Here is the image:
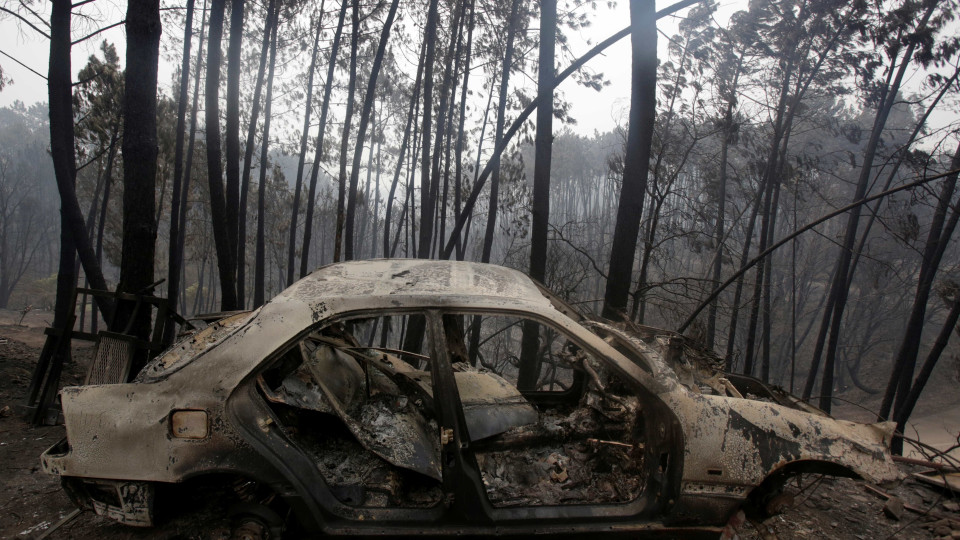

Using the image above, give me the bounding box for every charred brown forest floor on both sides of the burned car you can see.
[0,310,960,540]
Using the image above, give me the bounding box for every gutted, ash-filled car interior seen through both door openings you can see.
[257,312,667,508]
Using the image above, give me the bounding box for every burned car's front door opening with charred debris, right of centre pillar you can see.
[443,314,645,507]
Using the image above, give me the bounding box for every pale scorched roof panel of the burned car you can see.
[263,259,552,322]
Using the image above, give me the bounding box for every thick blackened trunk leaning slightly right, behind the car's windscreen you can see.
[603,0,657,320]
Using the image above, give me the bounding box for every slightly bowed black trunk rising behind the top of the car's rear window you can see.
[204,0,239,311]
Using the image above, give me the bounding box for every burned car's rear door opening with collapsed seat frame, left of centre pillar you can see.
[258,315,442,508]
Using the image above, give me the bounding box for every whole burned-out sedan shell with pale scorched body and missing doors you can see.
[41,260,899,537]
